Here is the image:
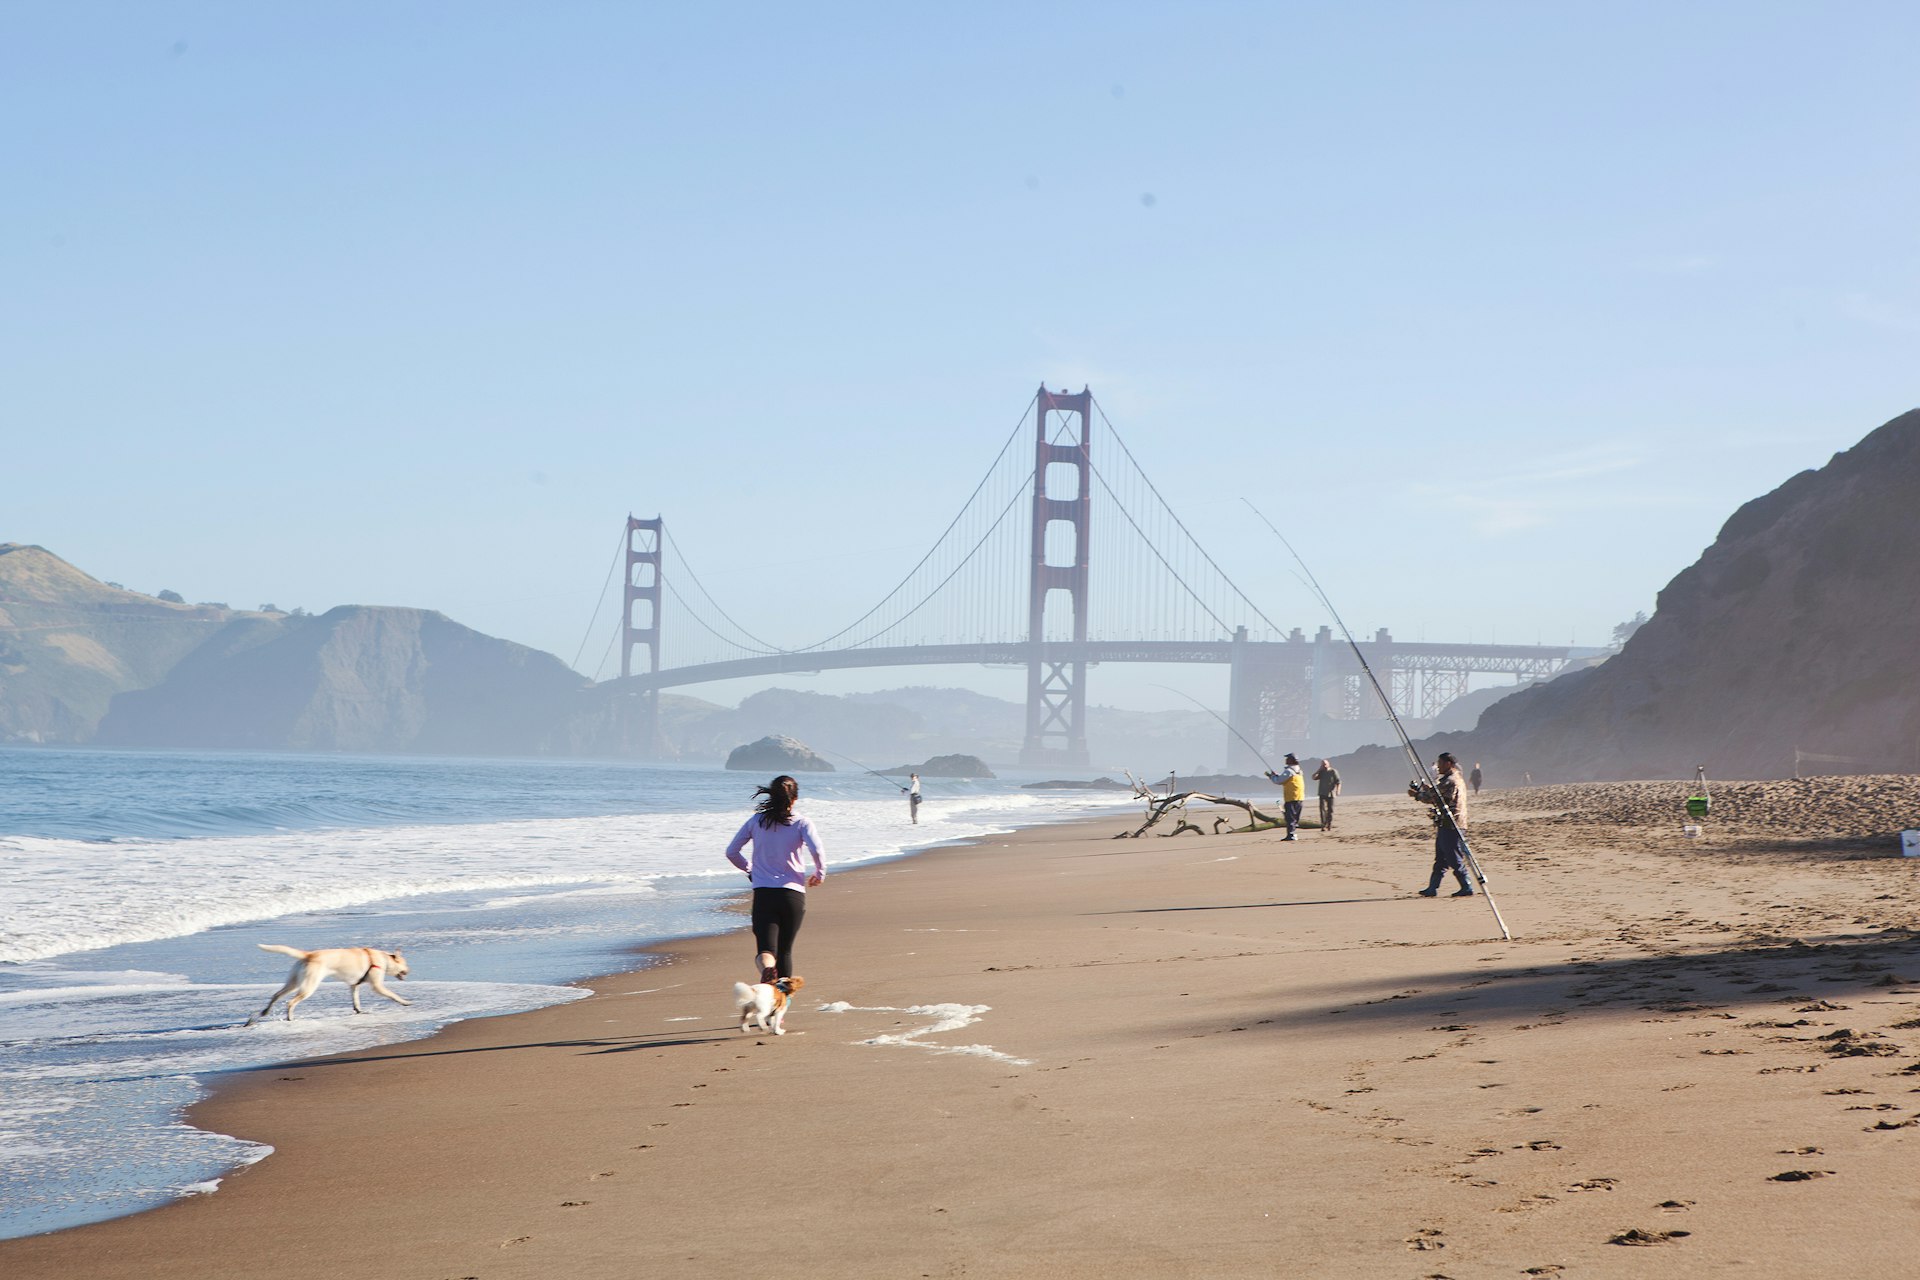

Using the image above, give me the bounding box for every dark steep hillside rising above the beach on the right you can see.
[1342,411,1920,787]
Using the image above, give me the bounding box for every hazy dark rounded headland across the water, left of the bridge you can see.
[94,604,588,754]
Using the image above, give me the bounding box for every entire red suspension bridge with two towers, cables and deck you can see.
[591,386,1592,768]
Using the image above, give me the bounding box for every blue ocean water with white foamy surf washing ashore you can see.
[0,748,1116,1238]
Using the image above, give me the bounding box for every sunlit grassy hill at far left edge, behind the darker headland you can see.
[0,543,249,743]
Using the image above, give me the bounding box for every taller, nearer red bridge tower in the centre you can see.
[1020,386,1092,768]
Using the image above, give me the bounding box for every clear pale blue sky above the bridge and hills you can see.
[0,2,1920,704]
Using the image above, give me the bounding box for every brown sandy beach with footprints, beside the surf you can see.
[0,779,1920,1280]
